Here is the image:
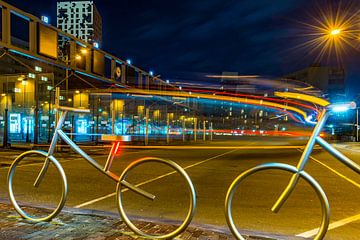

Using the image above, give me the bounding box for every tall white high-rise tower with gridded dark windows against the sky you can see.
[57,1,102,46]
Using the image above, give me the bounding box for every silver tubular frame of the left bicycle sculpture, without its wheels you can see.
[34,110,150,200]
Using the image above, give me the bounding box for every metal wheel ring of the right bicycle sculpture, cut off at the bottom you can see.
[225,163,330,240]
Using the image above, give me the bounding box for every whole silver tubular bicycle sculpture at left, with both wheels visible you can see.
[8,106,196,239]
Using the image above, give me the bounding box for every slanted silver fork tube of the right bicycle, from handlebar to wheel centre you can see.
[271,108,329,213]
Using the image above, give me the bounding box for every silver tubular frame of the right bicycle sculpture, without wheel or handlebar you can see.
[271,108,360,213]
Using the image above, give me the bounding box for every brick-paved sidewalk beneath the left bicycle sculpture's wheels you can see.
[0,202,294,240]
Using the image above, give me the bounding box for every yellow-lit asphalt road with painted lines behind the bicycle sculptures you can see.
[0,137,360,239]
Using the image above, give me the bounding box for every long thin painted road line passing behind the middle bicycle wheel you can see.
[74,149,237,208]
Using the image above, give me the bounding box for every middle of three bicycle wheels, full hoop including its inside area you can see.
[116,157,196,239]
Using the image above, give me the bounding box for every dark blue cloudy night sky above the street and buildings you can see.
[7,0,360,95]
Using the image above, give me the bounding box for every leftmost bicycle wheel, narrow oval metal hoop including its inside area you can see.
[7,150,68,222]
